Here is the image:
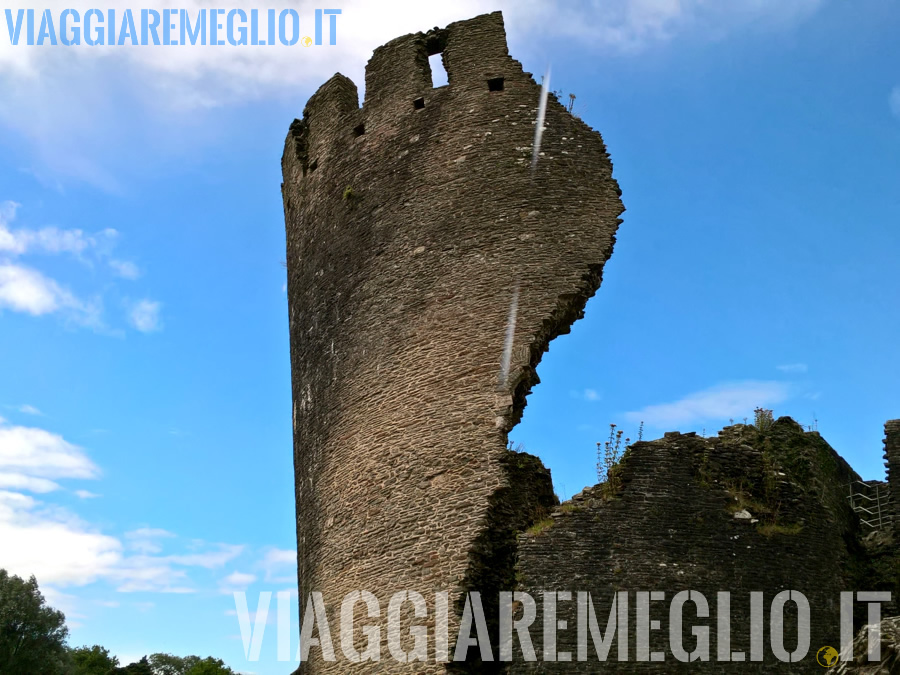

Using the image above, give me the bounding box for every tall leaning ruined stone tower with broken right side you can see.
[283,12,623,673]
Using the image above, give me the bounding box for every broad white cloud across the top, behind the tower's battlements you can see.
[0,0,822,190]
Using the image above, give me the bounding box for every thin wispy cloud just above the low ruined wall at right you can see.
[625,381,788,428]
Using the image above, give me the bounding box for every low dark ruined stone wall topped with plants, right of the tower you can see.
[511,418,867,673]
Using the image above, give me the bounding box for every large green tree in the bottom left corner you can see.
[0,569,69,675]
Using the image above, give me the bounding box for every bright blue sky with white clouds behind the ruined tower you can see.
[0,0,900,675]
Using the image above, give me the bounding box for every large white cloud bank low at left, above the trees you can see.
[0,424,250,593]
